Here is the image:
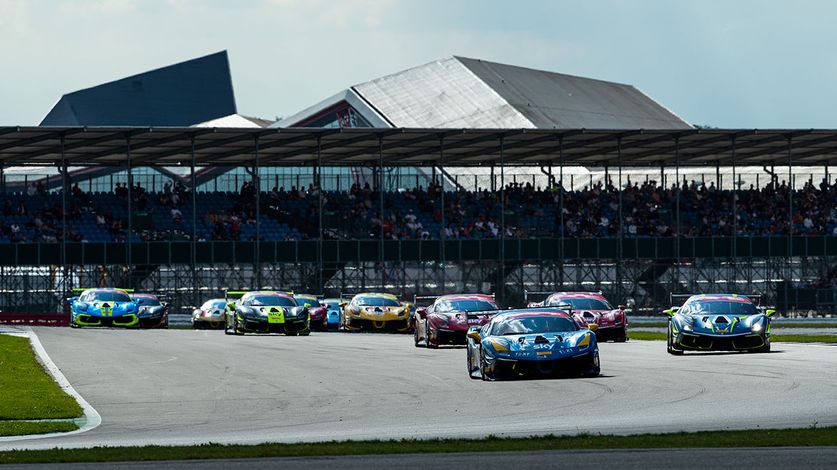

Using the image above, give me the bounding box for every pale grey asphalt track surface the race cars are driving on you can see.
[0,328,837,452]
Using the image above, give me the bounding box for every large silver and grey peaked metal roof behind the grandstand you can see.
[274,57,692,129]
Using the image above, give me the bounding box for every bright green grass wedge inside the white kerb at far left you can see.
[0,335,83,420]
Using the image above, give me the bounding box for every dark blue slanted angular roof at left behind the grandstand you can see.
[40,51,236,126]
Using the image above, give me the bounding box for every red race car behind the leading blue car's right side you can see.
[526,292,628,343]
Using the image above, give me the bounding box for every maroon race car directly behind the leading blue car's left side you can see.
[413,294,500,348]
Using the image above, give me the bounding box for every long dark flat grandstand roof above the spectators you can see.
[0,127,837,166]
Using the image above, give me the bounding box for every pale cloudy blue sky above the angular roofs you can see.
[0,0,837,129]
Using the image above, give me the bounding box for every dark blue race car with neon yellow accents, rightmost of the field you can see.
[663,294,776,355]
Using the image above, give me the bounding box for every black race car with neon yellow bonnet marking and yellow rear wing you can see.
[224,291,311,336]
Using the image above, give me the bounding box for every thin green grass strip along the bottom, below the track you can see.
[0,427,837,464]
